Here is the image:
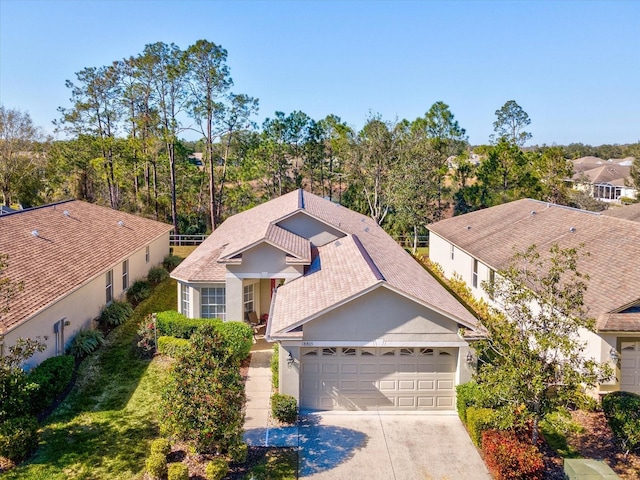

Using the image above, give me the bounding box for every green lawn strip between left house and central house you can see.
[3,280,177,480]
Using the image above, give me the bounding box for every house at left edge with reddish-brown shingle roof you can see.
[0,200,172,367]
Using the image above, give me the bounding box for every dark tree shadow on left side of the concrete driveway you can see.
[298,415,369,477]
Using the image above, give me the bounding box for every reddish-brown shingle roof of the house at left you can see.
[0,200,172,333]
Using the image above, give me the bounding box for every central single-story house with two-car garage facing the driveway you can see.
[171,190,476,410]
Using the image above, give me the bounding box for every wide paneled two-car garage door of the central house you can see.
[300,347,458,410]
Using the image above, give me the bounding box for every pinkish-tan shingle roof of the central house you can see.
[171,190,476,335]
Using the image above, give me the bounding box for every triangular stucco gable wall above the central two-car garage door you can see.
[303,287,460,342]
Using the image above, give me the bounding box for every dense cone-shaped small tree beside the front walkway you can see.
[161,326,245,453]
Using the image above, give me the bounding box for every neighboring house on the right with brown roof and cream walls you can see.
[429,199,640,393]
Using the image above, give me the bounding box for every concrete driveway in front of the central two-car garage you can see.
[298,412,491,480]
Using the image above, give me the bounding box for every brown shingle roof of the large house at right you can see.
[429,199,640,331]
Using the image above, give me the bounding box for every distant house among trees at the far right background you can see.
[571,157,638,202]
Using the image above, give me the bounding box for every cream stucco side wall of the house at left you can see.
[4,233,169,368]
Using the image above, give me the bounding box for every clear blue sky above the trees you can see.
[0,0,640,145]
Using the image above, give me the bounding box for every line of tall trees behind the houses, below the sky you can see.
[0,40,640,238]
